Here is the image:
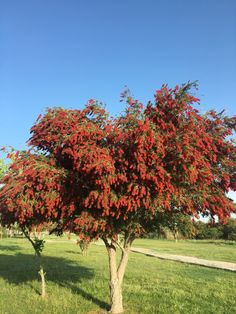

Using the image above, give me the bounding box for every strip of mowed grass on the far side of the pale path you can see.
[133,239,236,263]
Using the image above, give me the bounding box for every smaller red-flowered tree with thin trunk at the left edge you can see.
[0,151,68,297]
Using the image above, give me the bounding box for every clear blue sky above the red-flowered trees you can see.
[0,0,236,149]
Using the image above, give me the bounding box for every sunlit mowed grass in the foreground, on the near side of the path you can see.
[0,239,236,314]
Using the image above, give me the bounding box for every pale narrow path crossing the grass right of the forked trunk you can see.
[131,247,236,271]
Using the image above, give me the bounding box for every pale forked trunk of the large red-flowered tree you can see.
[104,241,130,314]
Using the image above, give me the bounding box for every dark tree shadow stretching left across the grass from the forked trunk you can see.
[0,253,109,310]
